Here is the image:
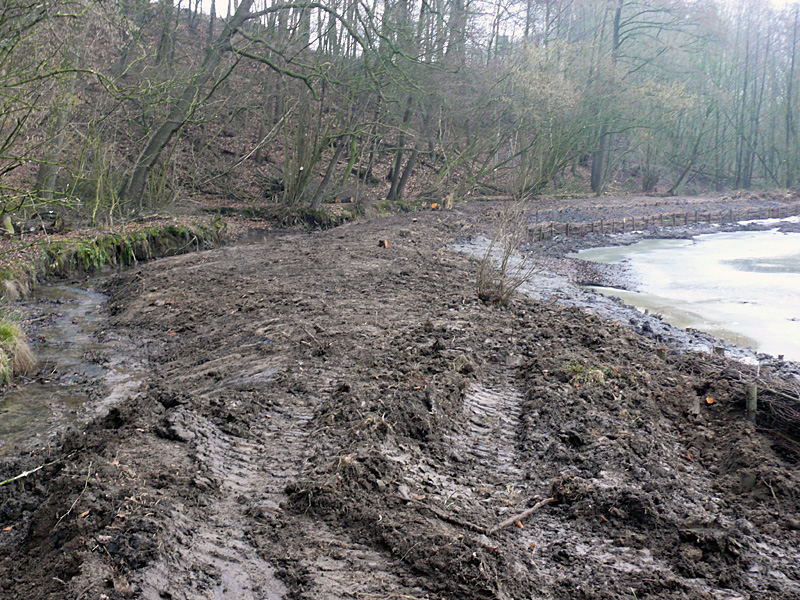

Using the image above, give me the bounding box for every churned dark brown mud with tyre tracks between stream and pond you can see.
[0,199,800,600]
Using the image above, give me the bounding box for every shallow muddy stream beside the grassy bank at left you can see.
[0,284,142,456]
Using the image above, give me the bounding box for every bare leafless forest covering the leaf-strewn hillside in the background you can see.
[0,0,800,225]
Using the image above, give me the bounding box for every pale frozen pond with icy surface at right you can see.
[573,230,800,361]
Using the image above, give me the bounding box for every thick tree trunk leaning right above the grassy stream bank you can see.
[122,0,254,210]
